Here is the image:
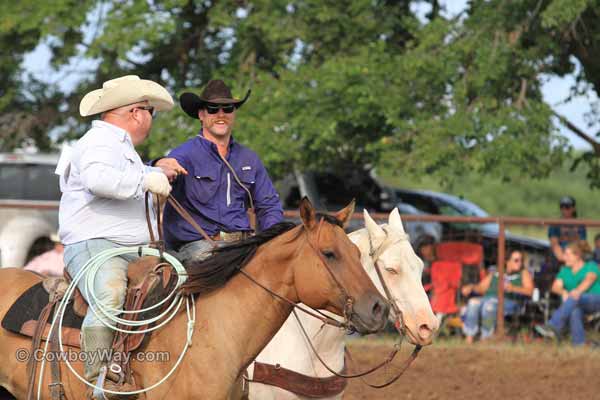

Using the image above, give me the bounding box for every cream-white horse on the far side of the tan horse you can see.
[248,209,438,400]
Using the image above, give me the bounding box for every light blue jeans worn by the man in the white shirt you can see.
[64,239,138,328]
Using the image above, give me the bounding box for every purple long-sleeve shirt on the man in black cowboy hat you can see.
[164,133,283,249]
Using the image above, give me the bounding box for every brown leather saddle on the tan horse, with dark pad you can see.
[2,257,177,400]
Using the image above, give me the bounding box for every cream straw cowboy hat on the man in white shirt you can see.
[79,75,173,117]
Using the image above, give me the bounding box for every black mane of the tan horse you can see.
[180,214,342,295]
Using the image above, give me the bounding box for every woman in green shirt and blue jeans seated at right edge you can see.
[535,242,600,346]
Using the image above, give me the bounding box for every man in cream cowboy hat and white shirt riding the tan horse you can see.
[57,75,174,399]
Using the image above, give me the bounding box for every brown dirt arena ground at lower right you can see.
[344,339,600,400]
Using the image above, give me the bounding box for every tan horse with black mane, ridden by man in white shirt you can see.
[0,199,389,400]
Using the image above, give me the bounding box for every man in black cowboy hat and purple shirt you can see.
[156,80,283,260]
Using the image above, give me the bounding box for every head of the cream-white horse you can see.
[352,208,439,346]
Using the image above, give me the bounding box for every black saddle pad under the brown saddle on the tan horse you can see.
[2,282,83,333]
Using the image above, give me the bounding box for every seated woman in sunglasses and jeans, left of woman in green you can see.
[461,250,533,344]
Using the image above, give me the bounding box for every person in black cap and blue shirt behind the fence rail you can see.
[548,196,587,264]
